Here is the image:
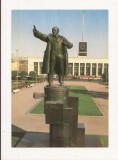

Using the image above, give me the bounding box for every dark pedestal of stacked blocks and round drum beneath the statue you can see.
[44,85,85,147]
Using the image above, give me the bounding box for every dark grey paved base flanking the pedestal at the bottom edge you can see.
[16,132,108,148]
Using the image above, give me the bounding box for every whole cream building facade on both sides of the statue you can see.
[12,56,109,77]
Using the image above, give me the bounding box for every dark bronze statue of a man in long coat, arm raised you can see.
[33,25,73,86]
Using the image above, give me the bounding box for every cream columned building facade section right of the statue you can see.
[68,56,108,77]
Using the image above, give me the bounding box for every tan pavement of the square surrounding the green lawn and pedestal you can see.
[12,81,108,135]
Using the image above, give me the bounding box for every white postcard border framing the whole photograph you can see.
[1,0,118,160]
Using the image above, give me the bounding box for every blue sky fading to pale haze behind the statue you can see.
[11,10,108,58]
